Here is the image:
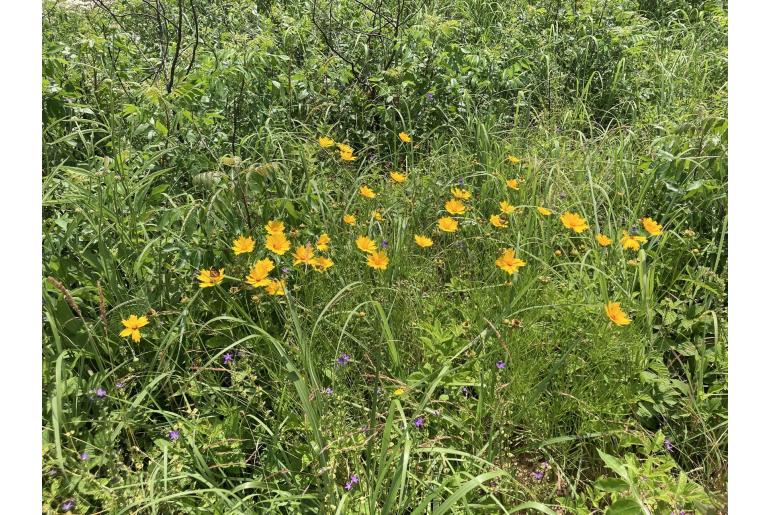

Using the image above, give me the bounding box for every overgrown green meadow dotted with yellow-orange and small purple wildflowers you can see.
[41,0,728,515]
